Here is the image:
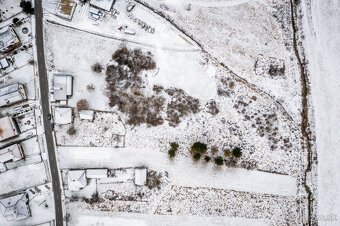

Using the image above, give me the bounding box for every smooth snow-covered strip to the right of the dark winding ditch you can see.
[303,0,340,225]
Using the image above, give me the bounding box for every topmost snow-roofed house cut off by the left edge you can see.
[0,26,21,54]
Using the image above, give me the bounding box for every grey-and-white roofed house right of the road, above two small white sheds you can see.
[52,74,73,101]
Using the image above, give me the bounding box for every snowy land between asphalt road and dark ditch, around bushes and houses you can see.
[41,0,318,225]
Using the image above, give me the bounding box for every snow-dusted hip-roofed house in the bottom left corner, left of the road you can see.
[0,193,31,221]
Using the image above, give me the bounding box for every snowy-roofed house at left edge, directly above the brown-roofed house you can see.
[0,83,27,107]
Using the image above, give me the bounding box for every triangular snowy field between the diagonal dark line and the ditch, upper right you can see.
[138,0,301,119]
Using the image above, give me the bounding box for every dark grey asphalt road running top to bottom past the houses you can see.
[35,0,63,226]
